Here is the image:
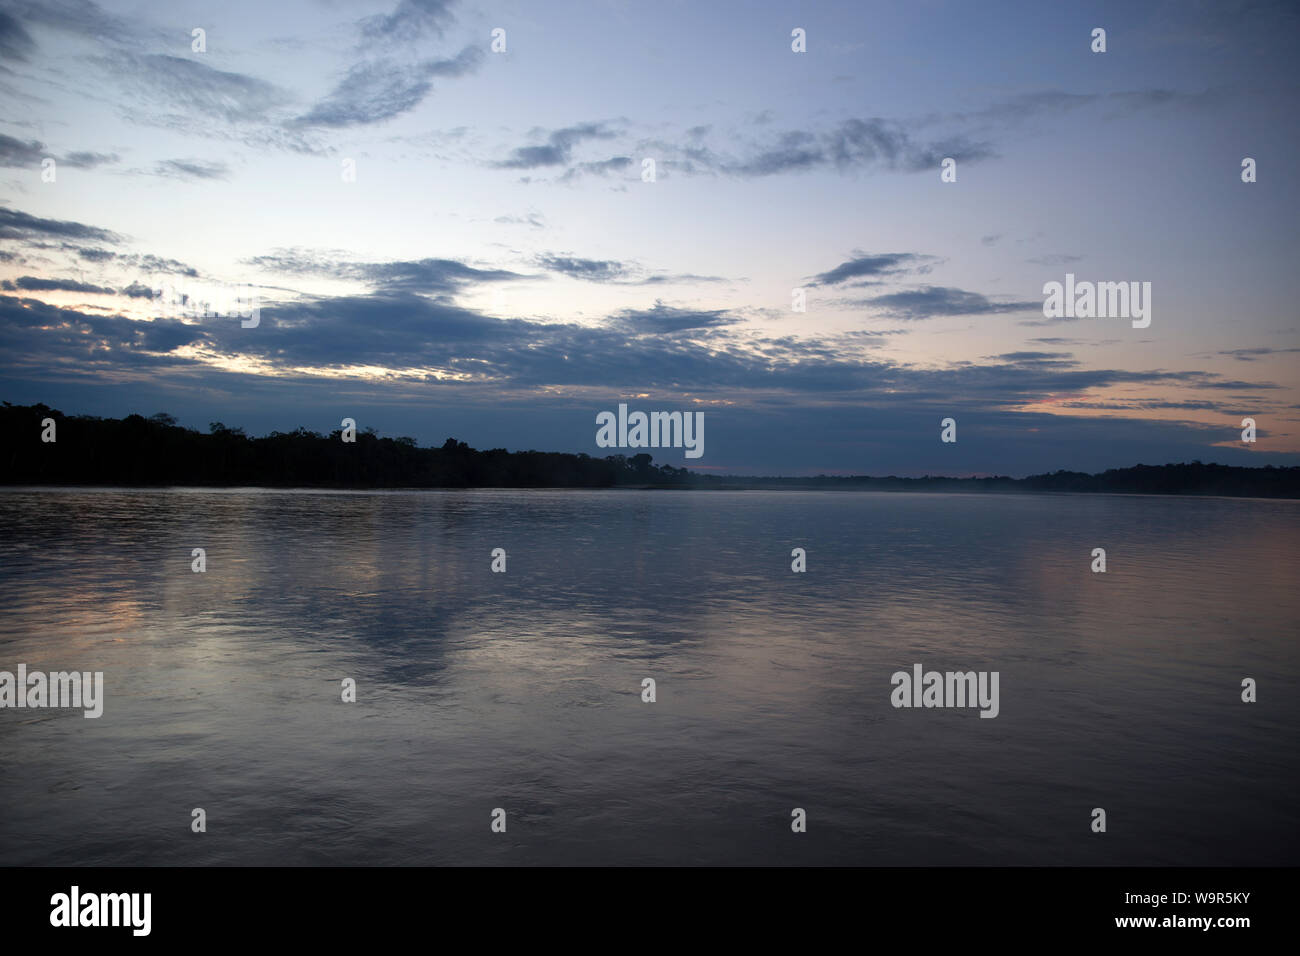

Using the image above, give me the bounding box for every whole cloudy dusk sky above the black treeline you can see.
[0,0,1300,476]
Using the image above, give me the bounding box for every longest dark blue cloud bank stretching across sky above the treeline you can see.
[0,291,1278,427]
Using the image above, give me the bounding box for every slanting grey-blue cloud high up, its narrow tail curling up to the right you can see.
[294,46,484,129]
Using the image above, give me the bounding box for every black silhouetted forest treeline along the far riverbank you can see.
[0,402,1300,498]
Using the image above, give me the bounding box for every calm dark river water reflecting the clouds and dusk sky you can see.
[0,489,1300,865]
